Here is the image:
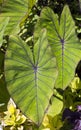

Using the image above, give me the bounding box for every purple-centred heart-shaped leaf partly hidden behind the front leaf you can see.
[34,5,81,88]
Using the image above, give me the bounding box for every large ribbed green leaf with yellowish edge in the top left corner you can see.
[0,0,36,34]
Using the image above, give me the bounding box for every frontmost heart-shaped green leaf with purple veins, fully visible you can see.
[5,30,57,125]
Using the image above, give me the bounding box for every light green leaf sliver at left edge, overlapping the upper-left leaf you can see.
[0,17,9,47]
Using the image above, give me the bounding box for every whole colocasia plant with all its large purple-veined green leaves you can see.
[0,0,81,130]
